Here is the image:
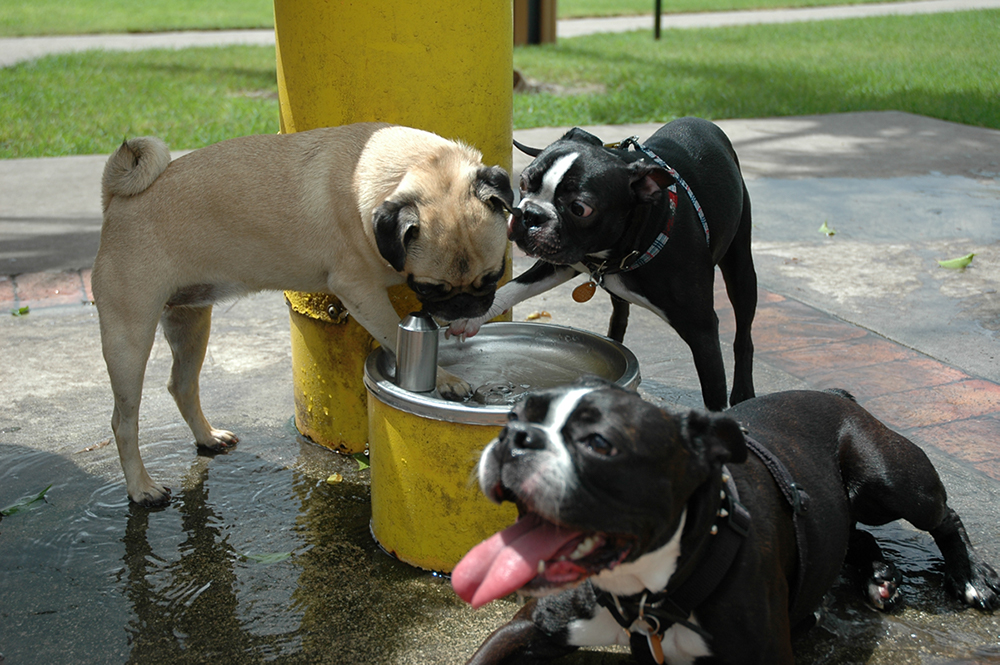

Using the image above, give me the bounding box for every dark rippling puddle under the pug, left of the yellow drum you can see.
[0,426,476,665]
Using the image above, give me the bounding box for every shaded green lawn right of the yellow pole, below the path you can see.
[514,11,1000,128]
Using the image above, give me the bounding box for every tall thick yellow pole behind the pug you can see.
[274,0,513,452]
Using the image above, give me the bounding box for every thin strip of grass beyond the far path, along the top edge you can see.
[0,0,916,37]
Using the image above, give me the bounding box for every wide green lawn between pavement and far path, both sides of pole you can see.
[0,11,1000,158]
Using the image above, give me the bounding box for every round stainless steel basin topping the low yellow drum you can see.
[365,322,640,425]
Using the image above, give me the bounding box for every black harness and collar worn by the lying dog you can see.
[594,437,809,665]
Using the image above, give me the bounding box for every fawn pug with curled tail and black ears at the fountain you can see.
[92,123,514,505]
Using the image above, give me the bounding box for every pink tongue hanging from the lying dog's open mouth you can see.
[451,513,581,607]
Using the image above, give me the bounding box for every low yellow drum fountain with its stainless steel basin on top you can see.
[365,323,639,572]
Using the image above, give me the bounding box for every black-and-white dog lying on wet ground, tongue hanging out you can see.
[452,380,1000,665]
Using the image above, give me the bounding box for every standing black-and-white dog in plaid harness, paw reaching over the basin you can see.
[449,118,757,411]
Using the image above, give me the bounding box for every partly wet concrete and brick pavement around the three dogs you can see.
[0,112,1000,665]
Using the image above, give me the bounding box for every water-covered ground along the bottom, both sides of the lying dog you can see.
[0,429,1000,665]
